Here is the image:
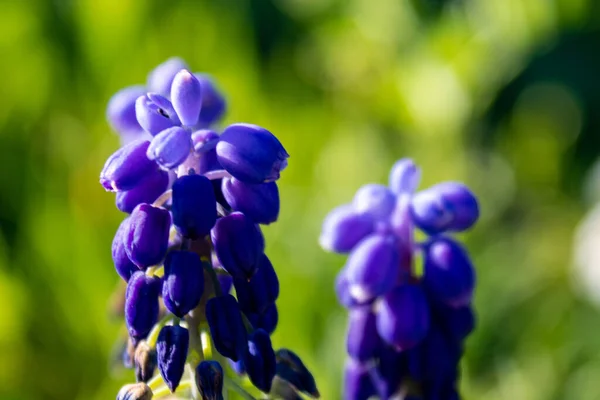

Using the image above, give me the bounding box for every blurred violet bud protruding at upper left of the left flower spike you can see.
[106,86,146,134]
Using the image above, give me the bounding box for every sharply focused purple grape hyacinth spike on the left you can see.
[100,58,318,400]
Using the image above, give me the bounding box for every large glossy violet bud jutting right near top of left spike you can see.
[217,124,289,183]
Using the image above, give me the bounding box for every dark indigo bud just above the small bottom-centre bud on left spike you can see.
[206,294,248,361]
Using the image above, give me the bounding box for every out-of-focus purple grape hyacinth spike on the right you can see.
[320,159,479,400]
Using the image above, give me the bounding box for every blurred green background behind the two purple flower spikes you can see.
[0,0,600,400]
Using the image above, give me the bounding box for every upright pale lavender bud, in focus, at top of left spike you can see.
[171,69,202,126]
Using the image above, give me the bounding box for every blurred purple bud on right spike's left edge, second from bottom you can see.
[346,306,381,362]
